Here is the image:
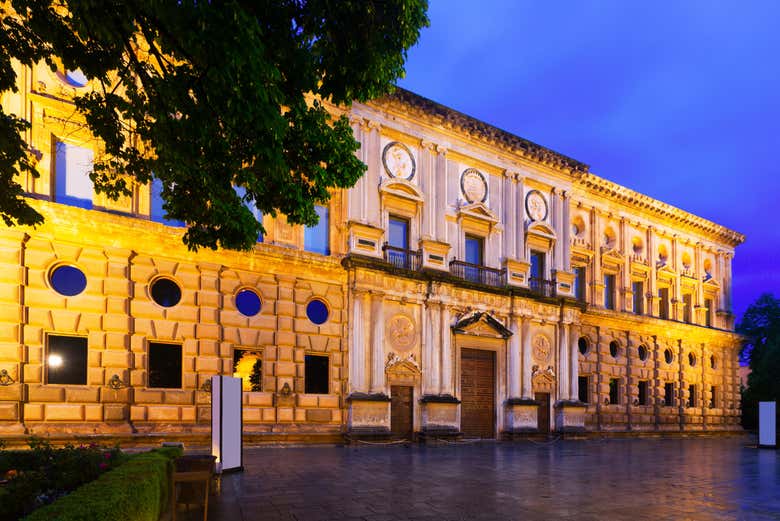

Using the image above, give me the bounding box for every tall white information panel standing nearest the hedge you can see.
[211,376,244,472]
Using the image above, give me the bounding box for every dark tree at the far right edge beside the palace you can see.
[736,293,780,428]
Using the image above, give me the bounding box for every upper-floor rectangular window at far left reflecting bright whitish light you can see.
[54,141,94,209]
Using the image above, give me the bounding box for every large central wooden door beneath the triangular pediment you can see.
[460,349,496,438]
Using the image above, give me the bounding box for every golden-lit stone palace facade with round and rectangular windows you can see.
[0,62,744,441]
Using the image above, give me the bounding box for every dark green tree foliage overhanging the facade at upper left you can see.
[0,0,428,249]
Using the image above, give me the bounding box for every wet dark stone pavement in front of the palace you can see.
[187,438,780,521]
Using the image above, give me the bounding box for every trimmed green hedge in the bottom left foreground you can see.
[25,447,181,521]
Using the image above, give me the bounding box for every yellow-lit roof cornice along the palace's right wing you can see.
[575,173,745,246]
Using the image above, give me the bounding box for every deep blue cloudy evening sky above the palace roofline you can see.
[399,0,780,318]
